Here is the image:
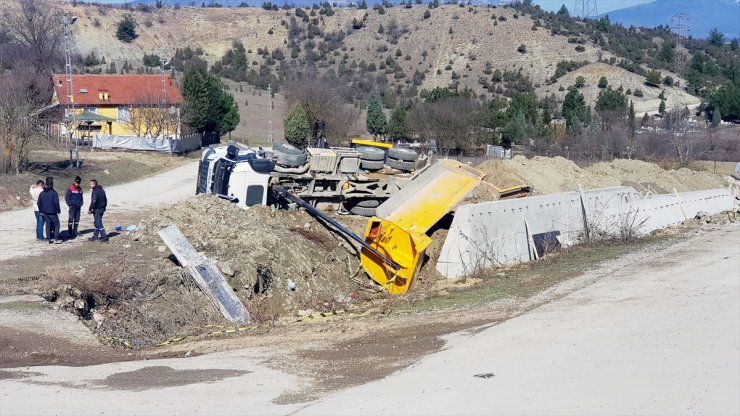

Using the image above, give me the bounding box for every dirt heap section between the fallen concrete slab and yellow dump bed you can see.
[131,196,358,321]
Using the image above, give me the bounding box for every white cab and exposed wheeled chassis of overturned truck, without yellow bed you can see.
[196,143,428,216]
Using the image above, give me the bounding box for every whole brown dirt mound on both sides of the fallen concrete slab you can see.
[45,195,364,347]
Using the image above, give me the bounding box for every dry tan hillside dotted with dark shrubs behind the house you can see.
[46,4,699,111]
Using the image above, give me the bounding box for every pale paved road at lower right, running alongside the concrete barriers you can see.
[298,225,740,415]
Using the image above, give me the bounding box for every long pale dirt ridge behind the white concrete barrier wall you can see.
[478,156,727,199]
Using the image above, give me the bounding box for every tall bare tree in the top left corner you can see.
[0,0,64,73]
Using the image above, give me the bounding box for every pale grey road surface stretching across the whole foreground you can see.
[0,224,740,415]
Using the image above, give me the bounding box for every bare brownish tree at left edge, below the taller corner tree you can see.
[0,69,52,174]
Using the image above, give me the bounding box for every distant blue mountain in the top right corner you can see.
[599,0,740,40]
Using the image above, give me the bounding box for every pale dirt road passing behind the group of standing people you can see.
[0,162,197,261]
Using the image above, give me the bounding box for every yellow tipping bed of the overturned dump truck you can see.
[360,159,485,294]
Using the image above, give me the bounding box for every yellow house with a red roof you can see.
[52,74,183,137]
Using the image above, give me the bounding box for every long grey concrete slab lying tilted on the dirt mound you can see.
[159,224,251,325]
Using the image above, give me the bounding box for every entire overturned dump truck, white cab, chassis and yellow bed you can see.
[197,145,530,294]
